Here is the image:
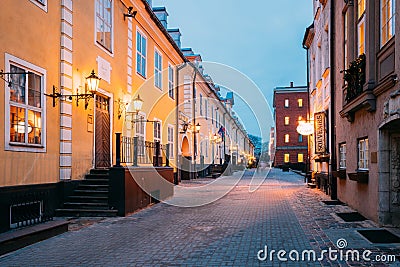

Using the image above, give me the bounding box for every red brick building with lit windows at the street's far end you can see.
[273,82,308,169]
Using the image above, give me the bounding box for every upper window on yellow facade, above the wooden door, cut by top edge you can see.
[96,0,112,52]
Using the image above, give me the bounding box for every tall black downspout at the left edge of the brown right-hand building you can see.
[329,0,337,199]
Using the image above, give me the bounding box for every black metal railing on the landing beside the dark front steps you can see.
[116,133,169,167]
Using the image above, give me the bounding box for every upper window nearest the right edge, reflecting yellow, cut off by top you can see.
[380,0,396,47]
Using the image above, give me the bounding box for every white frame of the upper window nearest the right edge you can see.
[379,0,396,48]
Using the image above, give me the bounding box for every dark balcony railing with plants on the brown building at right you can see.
[342,54,366,103]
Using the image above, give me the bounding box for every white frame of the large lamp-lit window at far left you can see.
[4,53,47,153]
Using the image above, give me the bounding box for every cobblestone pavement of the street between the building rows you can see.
[0,169,400,266]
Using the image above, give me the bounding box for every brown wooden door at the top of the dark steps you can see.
[95,96,111,168]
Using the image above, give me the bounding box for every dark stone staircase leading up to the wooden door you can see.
[56,169,117,217]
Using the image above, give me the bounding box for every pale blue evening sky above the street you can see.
[153,0,312,138]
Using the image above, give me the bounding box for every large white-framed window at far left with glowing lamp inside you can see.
[5,54,46,152]
